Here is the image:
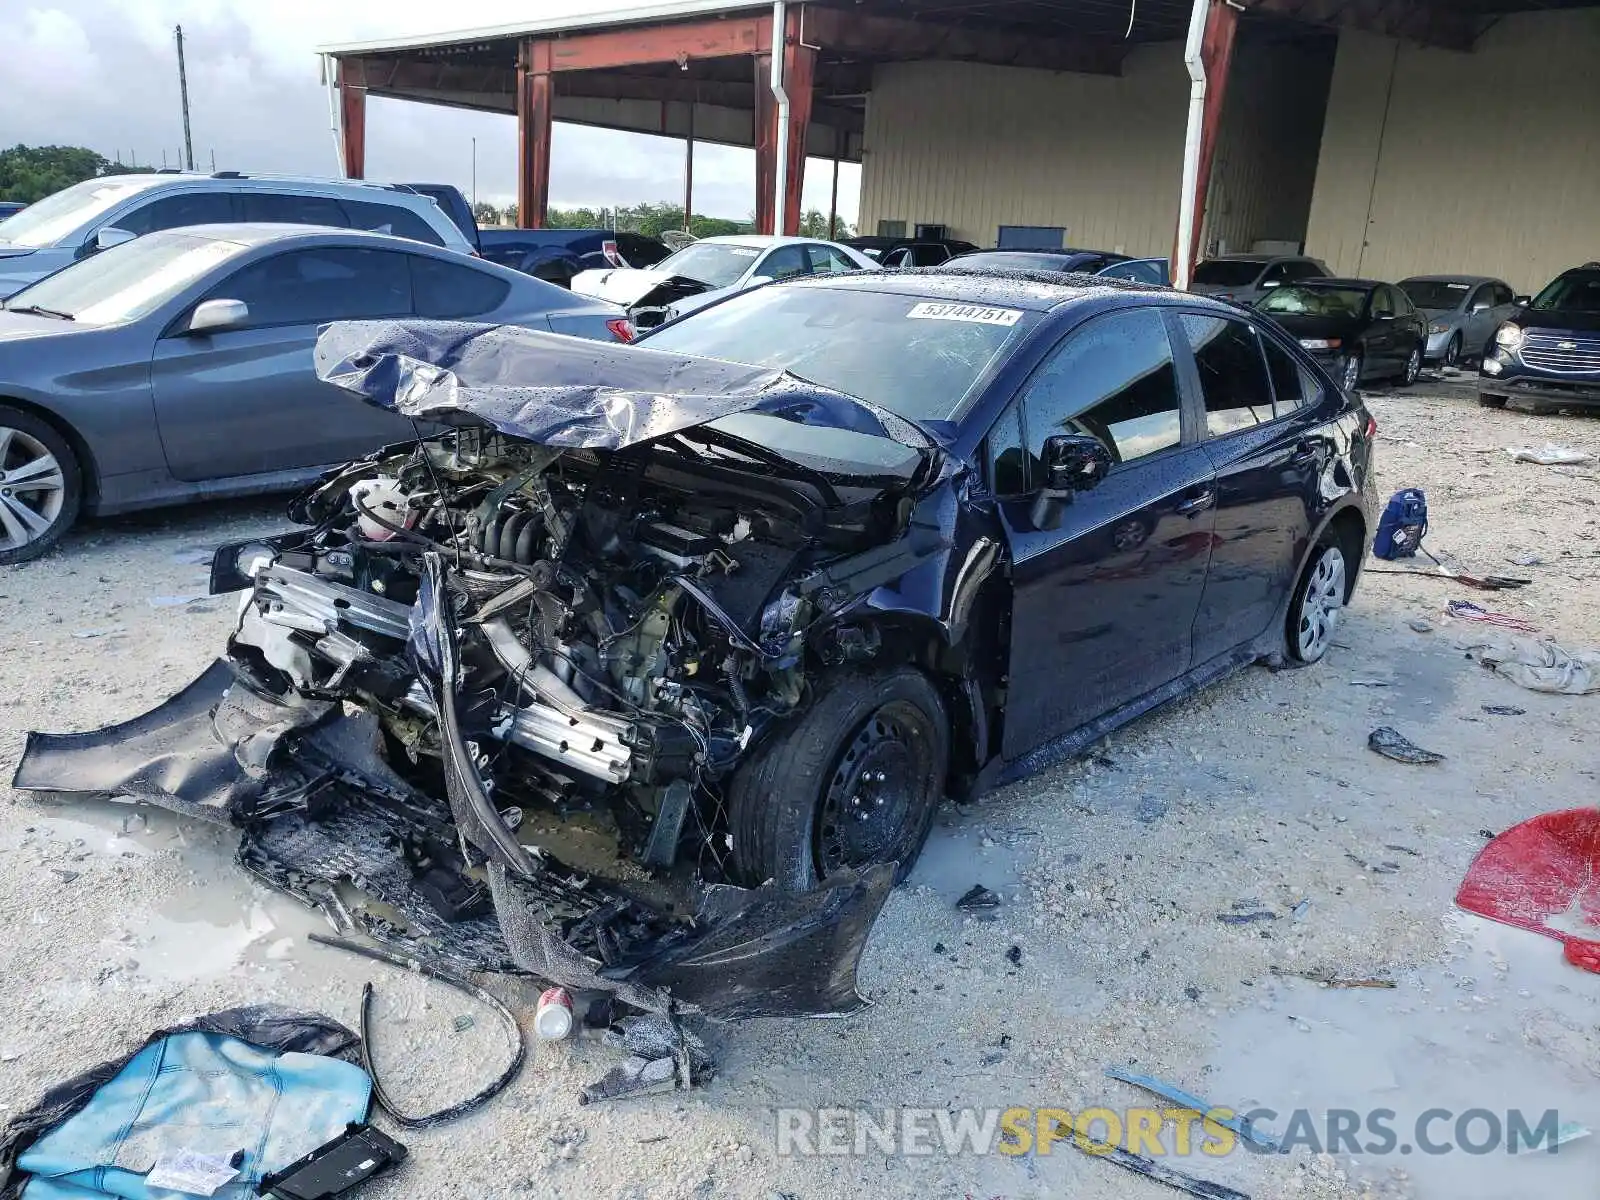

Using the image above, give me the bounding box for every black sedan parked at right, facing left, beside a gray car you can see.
[1254,278,1427,392]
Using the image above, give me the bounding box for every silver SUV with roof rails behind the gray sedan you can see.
[0,171,472,299]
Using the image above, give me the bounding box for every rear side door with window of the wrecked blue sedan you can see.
[1179,312,1336,666]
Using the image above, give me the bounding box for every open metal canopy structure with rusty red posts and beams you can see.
[322,0,1594,232]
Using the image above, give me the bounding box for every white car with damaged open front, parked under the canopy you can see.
[573,235,880,330]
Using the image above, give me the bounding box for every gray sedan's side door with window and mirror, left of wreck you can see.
[150,245,413,480]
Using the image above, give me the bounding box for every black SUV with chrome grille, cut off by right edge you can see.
[1478,262,1600,413]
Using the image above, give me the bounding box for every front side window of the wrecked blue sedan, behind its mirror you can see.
[1022,309,1182,478]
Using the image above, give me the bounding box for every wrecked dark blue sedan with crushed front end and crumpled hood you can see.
[16,270,1376,1016]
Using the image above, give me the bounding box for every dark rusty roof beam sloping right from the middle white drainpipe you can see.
[805,5,1126,75]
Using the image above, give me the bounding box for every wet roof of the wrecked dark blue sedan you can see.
[778,266,1177,312]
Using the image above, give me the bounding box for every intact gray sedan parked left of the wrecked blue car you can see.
[0,224,626,563]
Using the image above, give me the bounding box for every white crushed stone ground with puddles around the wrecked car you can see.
[0,378,1600,1200]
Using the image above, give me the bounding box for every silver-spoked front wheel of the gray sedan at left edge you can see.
[0,405,83,566]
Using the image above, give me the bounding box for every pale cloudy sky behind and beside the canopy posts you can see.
[0,0,861,221]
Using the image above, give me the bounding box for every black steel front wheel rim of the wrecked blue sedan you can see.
[816,704,926,875]
